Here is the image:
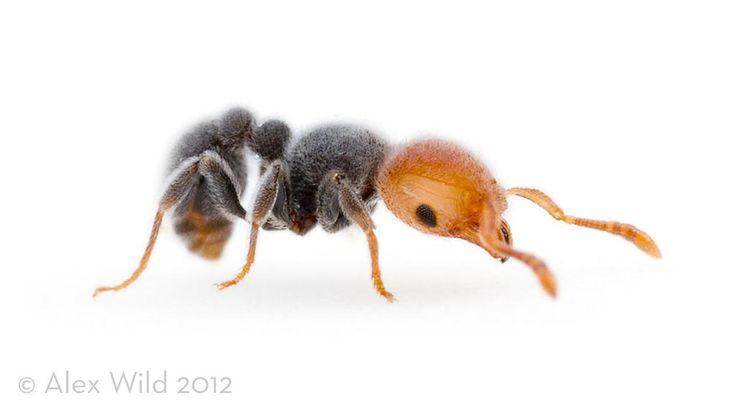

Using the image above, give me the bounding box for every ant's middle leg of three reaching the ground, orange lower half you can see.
[217,161,284,290]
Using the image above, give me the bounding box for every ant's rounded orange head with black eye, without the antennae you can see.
[378,140,511,252]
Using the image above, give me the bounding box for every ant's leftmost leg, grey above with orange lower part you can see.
[94,157,199,297]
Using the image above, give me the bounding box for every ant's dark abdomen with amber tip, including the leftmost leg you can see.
[95,109,282,295]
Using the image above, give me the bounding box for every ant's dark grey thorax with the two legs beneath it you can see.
[218,125,393,301]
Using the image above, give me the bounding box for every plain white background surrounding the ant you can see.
[0,0,736,402]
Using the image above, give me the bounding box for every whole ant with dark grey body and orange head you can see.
[95,109,661,301]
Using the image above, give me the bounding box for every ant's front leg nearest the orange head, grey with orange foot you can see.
[329,172,396,302]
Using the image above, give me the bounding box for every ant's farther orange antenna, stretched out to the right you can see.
[506,188,662,257]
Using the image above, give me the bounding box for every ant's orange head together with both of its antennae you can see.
[378,140,660,296]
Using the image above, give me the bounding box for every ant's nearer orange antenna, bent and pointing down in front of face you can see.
[480,206,557,297]
